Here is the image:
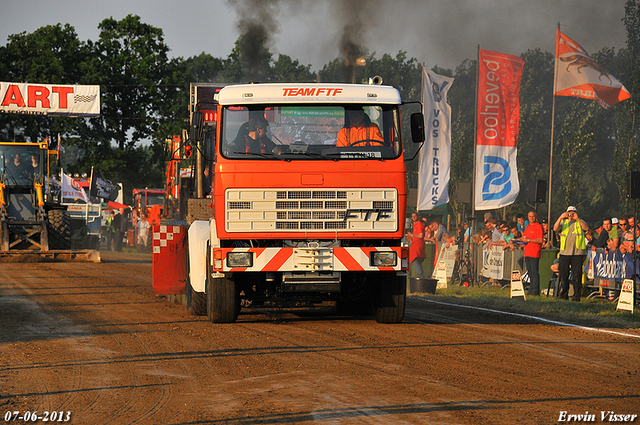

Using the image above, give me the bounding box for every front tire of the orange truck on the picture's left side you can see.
[207,273,240,323]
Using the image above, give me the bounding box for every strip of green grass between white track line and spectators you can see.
[412,285,640,329]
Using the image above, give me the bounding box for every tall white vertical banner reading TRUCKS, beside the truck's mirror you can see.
[418,67,453,210]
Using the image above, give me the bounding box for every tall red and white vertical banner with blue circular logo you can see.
[474,50,524,210]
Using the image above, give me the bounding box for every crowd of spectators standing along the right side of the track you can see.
[407,206,640,301]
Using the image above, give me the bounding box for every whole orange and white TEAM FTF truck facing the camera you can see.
[154,83,424,323]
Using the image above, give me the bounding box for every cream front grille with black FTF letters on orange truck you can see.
[225,189,398,235]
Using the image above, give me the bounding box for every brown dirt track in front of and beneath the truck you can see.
[0,253,640,424]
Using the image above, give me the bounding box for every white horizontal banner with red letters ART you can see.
[0,81,100,117]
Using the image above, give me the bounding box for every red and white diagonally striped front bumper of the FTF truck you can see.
[212,247,409,272]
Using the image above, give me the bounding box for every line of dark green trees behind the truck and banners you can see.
[0,0,640,222]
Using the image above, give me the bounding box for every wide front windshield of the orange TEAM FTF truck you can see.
[221,104,402,160]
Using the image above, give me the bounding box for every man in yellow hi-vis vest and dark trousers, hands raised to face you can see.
[553,207,589,301]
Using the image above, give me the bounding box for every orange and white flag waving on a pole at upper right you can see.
[555,28,631,109]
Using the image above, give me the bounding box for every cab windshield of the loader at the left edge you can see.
[0,145,42,186]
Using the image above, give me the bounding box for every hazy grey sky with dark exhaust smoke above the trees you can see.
[0,0,626,72]
